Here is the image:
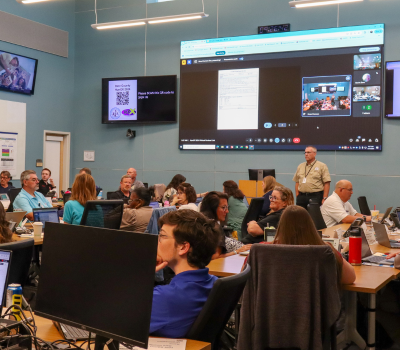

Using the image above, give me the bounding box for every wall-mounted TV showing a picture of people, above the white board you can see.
[0,50,38,95]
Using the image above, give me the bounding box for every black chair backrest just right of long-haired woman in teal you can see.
[81,200,124,230]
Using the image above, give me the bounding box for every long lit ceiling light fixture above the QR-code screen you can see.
[92,12,209,29]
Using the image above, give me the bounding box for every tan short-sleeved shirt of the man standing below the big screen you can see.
[293,160,331,193]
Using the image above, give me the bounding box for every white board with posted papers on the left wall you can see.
[0,100,26,180]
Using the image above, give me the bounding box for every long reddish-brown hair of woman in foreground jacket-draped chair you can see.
[274,205,325,245]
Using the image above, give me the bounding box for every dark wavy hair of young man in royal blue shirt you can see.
[158,209,220,269]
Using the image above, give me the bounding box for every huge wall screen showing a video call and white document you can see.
[179,24,384,151]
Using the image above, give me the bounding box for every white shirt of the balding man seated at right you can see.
[321,192,357,227]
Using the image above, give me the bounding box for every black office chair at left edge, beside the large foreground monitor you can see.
[0,238,35,305]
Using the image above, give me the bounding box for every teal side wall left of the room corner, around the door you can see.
[0,0,75,187]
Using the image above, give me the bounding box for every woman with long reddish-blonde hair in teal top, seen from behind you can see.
[63,173,96,225]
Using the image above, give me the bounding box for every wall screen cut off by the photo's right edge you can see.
[385,61,400,118]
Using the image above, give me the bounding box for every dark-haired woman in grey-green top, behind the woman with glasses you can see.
[223,180,247,239]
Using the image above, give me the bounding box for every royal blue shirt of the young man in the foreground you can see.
[150,268,217,338]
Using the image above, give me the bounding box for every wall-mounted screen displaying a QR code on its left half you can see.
[102,75,176,125]
